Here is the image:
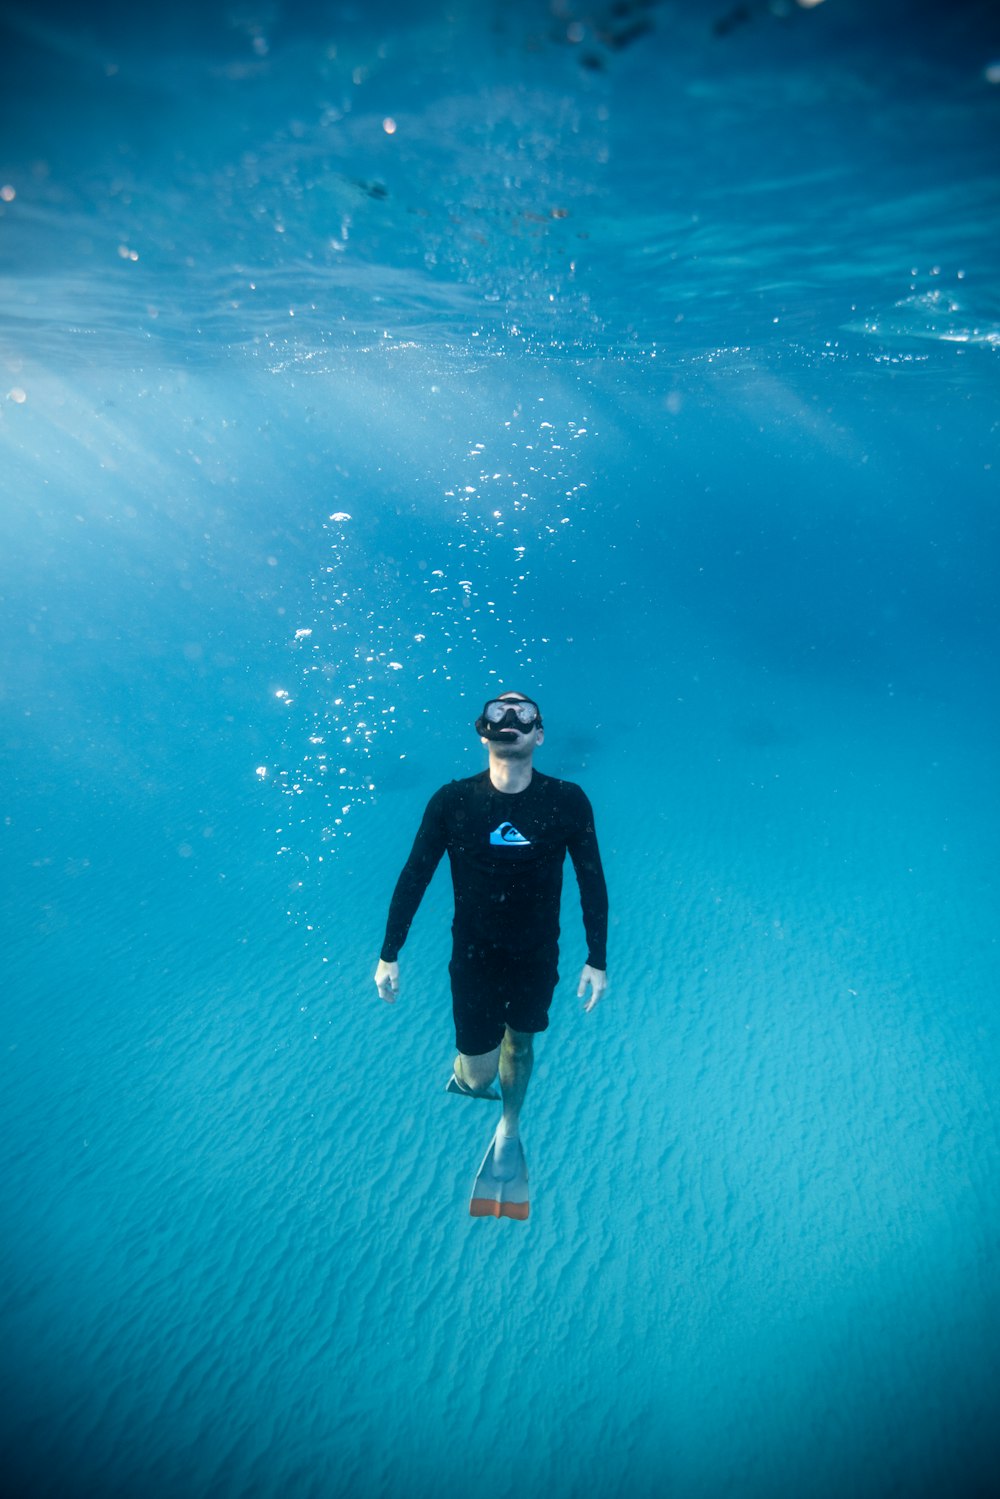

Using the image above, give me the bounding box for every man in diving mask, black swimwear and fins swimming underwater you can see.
[375,693,607,1219]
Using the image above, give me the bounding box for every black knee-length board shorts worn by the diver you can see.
[448,937,559,1057]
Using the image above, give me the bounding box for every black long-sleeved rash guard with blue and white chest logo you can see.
[382,770,607,970]
